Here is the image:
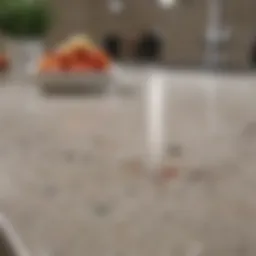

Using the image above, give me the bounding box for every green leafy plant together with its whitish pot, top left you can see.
[0,0,50,75]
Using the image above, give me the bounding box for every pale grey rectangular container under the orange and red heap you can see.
[38,73,112,94]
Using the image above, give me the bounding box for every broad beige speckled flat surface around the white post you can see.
[0,68,256,256]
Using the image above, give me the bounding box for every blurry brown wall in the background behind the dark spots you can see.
[47,0,256,67]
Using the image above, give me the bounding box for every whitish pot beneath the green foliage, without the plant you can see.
[7,39,43,78]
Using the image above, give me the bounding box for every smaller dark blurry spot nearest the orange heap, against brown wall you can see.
[103,34,123,59]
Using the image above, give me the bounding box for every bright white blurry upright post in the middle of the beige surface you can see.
[145,74,165,171]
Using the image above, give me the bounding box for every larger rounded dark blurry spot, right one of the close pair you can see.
[136,32,162,62]
